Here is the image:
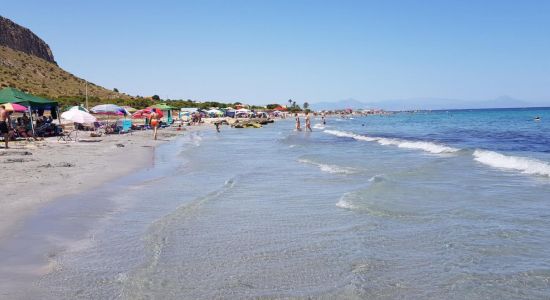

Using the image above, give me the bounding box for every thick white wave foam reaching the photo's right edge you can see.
[473,150,550,177]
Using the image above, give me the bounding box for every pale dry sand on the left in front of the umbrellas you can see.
[0,126,197,240]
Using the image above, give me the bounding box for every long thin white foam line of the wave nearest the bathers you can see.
[324,130,460,154]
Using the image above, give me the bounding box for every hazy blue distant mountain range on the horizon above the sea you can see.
[311,96,550,111]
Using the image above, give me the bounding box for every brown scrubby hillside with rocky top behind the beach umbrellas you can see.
[0,16,130,99]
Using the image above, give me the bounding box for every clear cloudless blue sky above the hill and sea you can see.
[0,0,550,104]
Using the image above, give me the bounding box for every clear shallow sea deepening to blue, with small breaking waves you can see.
[0,108,550,299]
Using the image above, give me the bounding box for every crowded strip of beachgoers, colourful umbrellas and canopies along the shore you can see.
[0,96,388,149]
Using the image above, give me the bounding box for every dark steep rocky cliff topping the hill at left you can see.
[0,16,55,63]
